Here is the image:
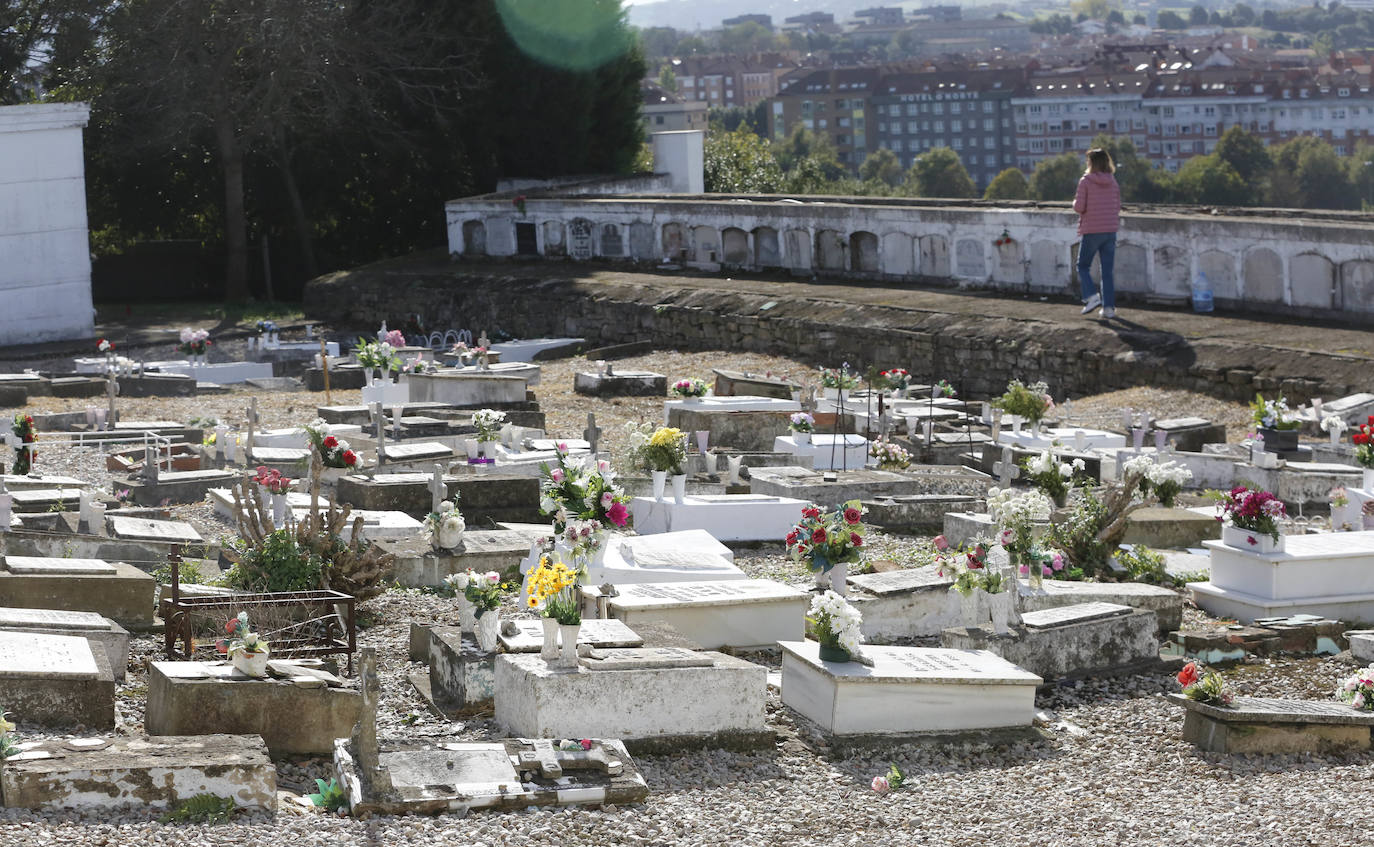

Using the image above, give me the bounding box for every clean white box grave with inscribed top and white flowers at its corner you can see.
[779,641,1043,737]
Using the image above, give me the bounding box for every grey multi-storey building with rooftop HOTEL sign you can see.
[870,69,1025,187]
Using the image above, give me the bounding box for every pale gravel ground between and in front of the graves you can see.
[0,348,1374,847]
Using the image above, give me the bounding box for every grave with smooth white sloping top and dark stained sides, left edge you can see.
[0,630,114,729]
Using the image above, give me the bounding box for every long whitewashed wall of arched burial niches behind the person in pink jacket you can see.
[447,195,1374,320]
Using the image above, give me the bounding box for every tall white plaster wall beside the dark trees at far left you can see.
[0,103,95,345]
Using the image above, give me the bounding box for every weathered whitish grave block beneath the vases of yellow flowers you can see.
[496,650,772,749]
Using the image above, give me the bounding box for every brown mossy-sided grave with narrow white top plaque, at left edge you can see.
[0,556,157,630]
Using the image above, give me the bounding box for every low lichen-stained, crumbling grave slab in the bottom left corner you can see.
[0,734,276,811]
